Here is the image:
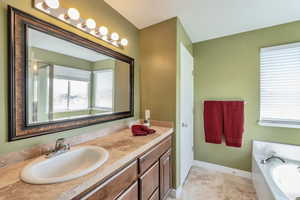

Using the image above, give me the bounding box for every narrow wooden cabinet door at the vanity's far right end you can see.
[159,149,172,199]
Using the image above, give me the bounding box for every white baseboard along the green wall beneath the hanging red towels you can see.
[193,160,251,179]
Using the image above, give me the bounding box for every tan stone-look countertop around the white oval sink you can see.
[0,126,173,200]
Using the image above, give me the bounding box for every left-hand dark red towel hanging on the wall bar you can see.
[203,101,223,144]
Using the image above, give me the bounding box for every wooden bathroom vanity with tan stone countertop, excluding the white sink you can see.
[0,124,173,200]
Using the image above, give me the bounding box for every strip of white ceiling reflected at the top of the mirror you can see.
[28,29,109,62]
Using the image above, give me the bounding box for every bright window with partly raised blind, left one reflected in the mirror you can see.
[53,66,90,112]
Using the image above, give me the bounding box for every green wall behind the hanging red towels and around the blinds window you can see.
[193,22,300,171]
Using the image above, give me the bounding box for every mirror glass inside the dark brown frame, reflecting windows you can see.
[27,29,130,124]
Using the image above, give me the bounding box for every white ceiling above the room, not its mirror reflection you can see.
[104,0,300,42]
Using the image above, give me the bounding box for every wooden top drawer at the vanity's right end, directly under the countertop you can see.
[139,137,171,174]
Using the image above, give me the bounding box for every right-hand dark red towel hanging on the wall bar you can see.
[223,101,244,147]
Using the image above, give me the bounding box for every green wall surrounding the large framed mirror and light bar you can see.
[0,0,139,154]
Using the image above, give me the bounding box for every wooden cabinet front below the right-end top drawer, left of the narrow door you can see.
[139,162,159,200]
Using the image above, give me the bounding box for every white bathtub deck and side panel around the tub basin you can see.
[252,141,300,200]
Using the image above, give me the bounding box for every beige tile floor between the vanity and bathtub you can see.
[167,167,257,200]
